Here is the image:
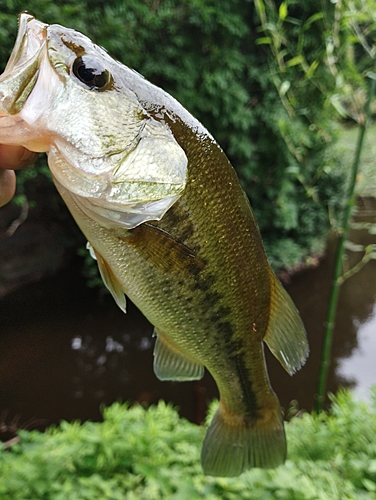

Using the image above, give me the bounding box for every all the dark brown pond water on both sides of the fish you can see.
[0,200,376,439]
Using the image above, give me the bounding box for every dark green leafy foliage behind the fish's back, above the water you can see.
[0,0,374,270]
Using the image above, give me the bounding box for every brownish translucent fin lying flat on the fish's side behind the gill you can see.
[122,223,205,274]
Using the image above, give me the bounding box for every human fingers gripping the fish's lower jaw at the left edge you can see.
[0,144,38,207]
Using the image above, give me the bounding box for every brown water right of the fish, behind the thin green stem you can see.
[273,195,376,408]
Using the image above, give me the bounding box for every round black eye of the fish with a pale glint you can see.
[72,55,111,90]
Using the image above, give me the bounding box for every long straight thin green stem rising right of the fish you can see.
[315,74,376,412]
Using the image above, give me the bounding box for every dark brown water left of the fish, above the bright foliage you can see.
[0,265,216,437]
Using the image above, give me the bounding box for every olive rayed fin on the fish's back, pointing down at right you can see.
[264,274,309,375]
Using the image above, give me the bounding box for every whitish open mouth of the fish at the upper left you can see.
[0,12,47,116]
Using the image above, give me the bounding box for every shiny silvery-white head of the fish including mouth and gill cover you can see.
[0,13,187,229]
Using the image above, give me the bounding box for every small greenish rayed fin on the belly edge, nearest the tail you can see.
[154,330,204,382]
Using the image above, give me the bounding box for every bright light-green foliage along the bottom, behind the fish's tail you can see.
[0,389,376,500]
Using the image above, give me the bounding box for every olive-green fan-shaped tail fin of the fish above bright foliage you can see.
[201,397,286,477]
